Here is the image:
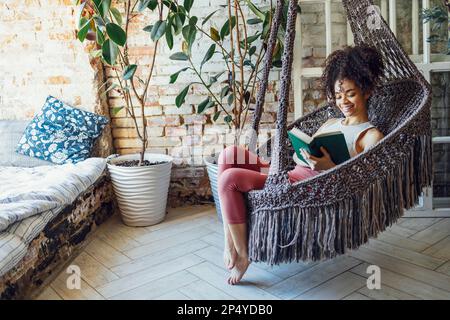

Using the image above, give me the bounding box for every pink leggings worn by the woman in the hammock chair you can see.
[218,146,319,224]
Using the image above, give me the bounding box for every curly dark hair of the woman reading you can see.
[320,46,384,101]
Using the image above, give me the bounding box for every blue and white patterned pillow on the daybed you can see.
[16,96,108,164]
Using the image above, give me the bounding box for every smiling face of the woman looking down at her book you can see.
[334,79,370,118]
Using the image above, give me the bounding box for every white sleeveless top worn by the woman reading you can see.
[294,118,375,166]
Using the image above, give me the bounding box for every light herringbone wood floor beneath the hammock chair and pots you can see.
[38,205,450,300]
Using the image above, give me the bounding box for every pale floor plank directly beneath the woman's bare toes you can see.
[188,262,278,300]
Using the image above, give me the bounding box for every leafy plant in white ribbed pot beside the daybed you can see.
[77,0,189,226]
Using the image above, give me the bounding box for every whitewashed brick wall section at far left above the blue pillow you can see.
[0,0,112,156]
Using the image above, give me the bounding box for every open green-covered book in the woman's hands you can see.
[288,128,350,165]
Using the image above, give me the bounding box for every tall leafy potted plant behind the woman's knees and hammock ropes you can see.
[170,0,287,219]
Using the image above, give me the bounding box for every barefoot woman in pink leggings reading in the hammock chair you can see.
[218,46,383,285]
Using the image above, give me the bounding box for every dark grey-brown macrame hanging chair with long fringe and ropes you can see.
[245,0,432,264]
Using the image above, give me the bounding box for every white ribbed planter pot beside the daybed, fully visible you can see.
[108,153,173,227]
